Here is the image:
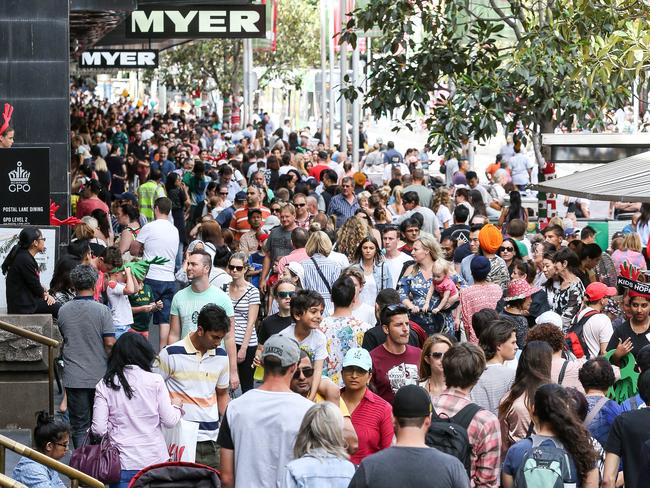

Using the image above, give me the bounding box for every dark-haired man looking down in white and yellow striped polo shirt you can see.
[157,304,230,469]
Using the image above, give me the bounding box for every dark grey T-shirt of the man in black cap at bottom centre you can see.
[346,446,469,488]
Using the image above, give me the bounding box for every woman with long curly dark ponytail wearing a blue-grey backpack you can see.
[501,383,599,488]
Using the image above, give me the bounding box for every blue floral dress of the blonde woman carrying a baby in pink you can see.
[399,271,454,335]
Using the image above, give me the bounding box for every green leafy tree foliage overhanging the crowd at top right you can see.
[341,0,650,162]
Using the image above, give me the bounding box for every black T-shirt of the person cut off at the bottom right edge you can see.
[605,408,650,488]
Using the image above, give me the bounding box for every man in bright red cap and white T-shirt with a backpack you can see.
[576,281,616,358]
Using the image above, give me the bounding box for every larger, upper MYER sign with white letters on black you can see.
[125,5,266,39]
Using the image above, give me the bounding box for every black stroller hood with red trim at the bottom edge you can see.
[129,461,221,488]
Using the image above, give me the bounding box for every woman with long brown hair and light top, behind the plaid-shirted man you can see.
[499,341,553,454]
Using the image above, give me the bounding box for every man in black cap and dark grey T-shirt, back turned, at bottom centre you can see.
[348,385,469,488]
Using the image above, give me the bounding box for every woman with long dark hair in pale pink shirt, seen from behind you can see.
[92,332,182,488]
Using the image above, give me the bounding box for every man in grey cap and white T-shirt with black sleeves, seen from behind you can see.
[217,334,313,488]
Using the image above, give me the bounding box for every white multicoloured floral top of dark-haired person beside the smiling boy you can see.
[320,317,372,388]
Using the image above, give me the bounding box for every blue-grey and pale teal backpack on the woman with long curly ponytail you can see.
[514,434,577,488]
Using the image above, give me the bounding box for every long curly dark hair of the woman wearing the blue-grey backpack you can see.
[534,383,598,483]
